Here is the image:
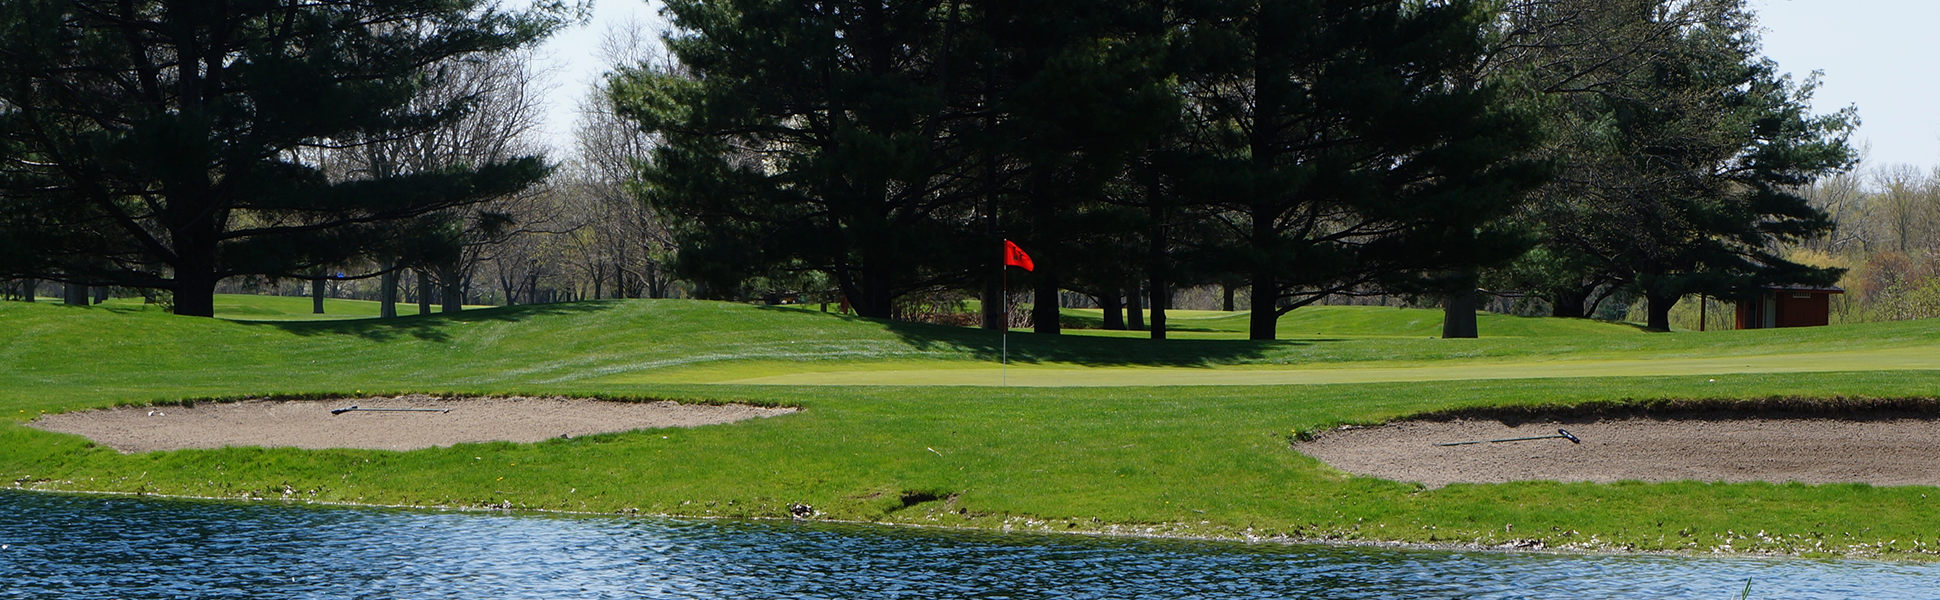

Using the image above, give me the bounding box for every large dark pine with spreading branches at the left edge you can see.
[0,0,563,317]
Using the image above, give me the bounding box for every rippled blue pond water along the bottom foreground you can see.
[0,491,1940,598]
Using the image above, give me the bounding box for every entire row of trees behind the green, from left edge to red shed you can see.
[0,0,1855,338]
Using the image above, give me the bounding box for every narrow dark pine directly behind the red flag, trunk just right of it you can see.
[976,0,1180,334]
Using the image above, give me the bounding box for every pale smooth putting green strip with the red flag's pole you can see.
[708,348,1940,386]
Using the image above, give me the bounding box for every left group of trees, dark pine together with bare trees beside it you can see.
[0,0,679,317]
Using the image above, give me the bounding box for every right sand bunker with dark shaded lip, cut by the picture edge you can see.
[1294,412,1940,487]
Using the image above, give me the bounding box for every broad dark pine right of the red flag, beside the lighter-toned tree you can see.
[1181,0,1546,340]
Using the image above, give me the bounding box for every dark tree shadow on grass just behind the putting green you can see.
[759,307,1325,367]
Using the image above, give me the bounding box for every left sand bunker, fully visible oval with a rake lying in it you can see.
[29,396,795,452]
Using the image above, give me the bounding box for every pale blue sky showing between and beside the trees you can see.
[545,0,1940,167]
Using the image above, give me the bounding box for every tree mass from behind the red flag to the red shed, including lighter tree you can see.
[611,0,1855,340]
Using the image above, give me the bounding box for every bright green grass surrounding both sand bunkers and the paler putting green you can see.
[0,299,1940,557]
